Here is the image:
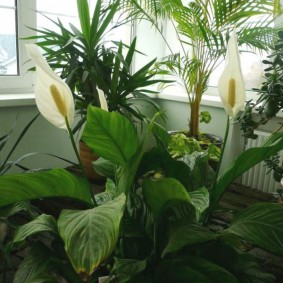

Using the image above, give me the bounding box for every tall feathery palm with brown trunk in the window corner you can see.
[123,0,280,137]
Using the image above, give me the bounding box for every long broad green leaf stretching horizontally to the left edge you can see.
[0,169,92,207]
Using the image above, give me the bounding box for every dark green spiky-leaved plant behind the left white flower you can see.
[26,0,166,132]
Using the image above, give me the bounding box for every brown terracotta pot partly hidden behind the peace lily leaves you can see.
[79,141,105,181]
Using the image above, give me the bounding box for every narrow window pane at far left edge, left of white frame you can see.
[0,6,18,76]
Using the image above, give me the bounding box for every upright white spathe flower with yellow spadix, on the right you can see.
[218,30,246,117]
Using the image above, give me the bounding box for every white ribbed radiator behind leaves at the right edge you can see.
[241,131,282,193]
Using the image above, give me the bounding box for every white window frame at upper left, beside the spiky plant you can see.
[0,0,36,95]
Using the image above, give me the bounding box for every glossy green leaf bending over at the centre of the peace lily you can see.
[142,178,191,221]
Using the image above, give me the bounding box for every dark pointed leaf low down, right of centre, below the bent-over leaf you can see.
[162,221,217,257]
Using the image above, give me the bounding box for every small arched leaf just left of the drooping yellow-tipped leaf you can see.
[13,214,57,243]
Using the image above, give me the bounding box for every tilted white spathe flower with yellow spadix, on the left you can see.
[26,44,75,129]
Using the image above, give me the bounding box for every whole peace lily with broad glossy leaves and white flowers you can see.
[0,26,283,283]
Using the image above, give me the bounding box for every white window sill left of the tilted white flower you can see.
[0,93,35,107]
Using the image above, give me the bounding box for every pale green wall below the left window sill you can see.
[0,106,76,172]
